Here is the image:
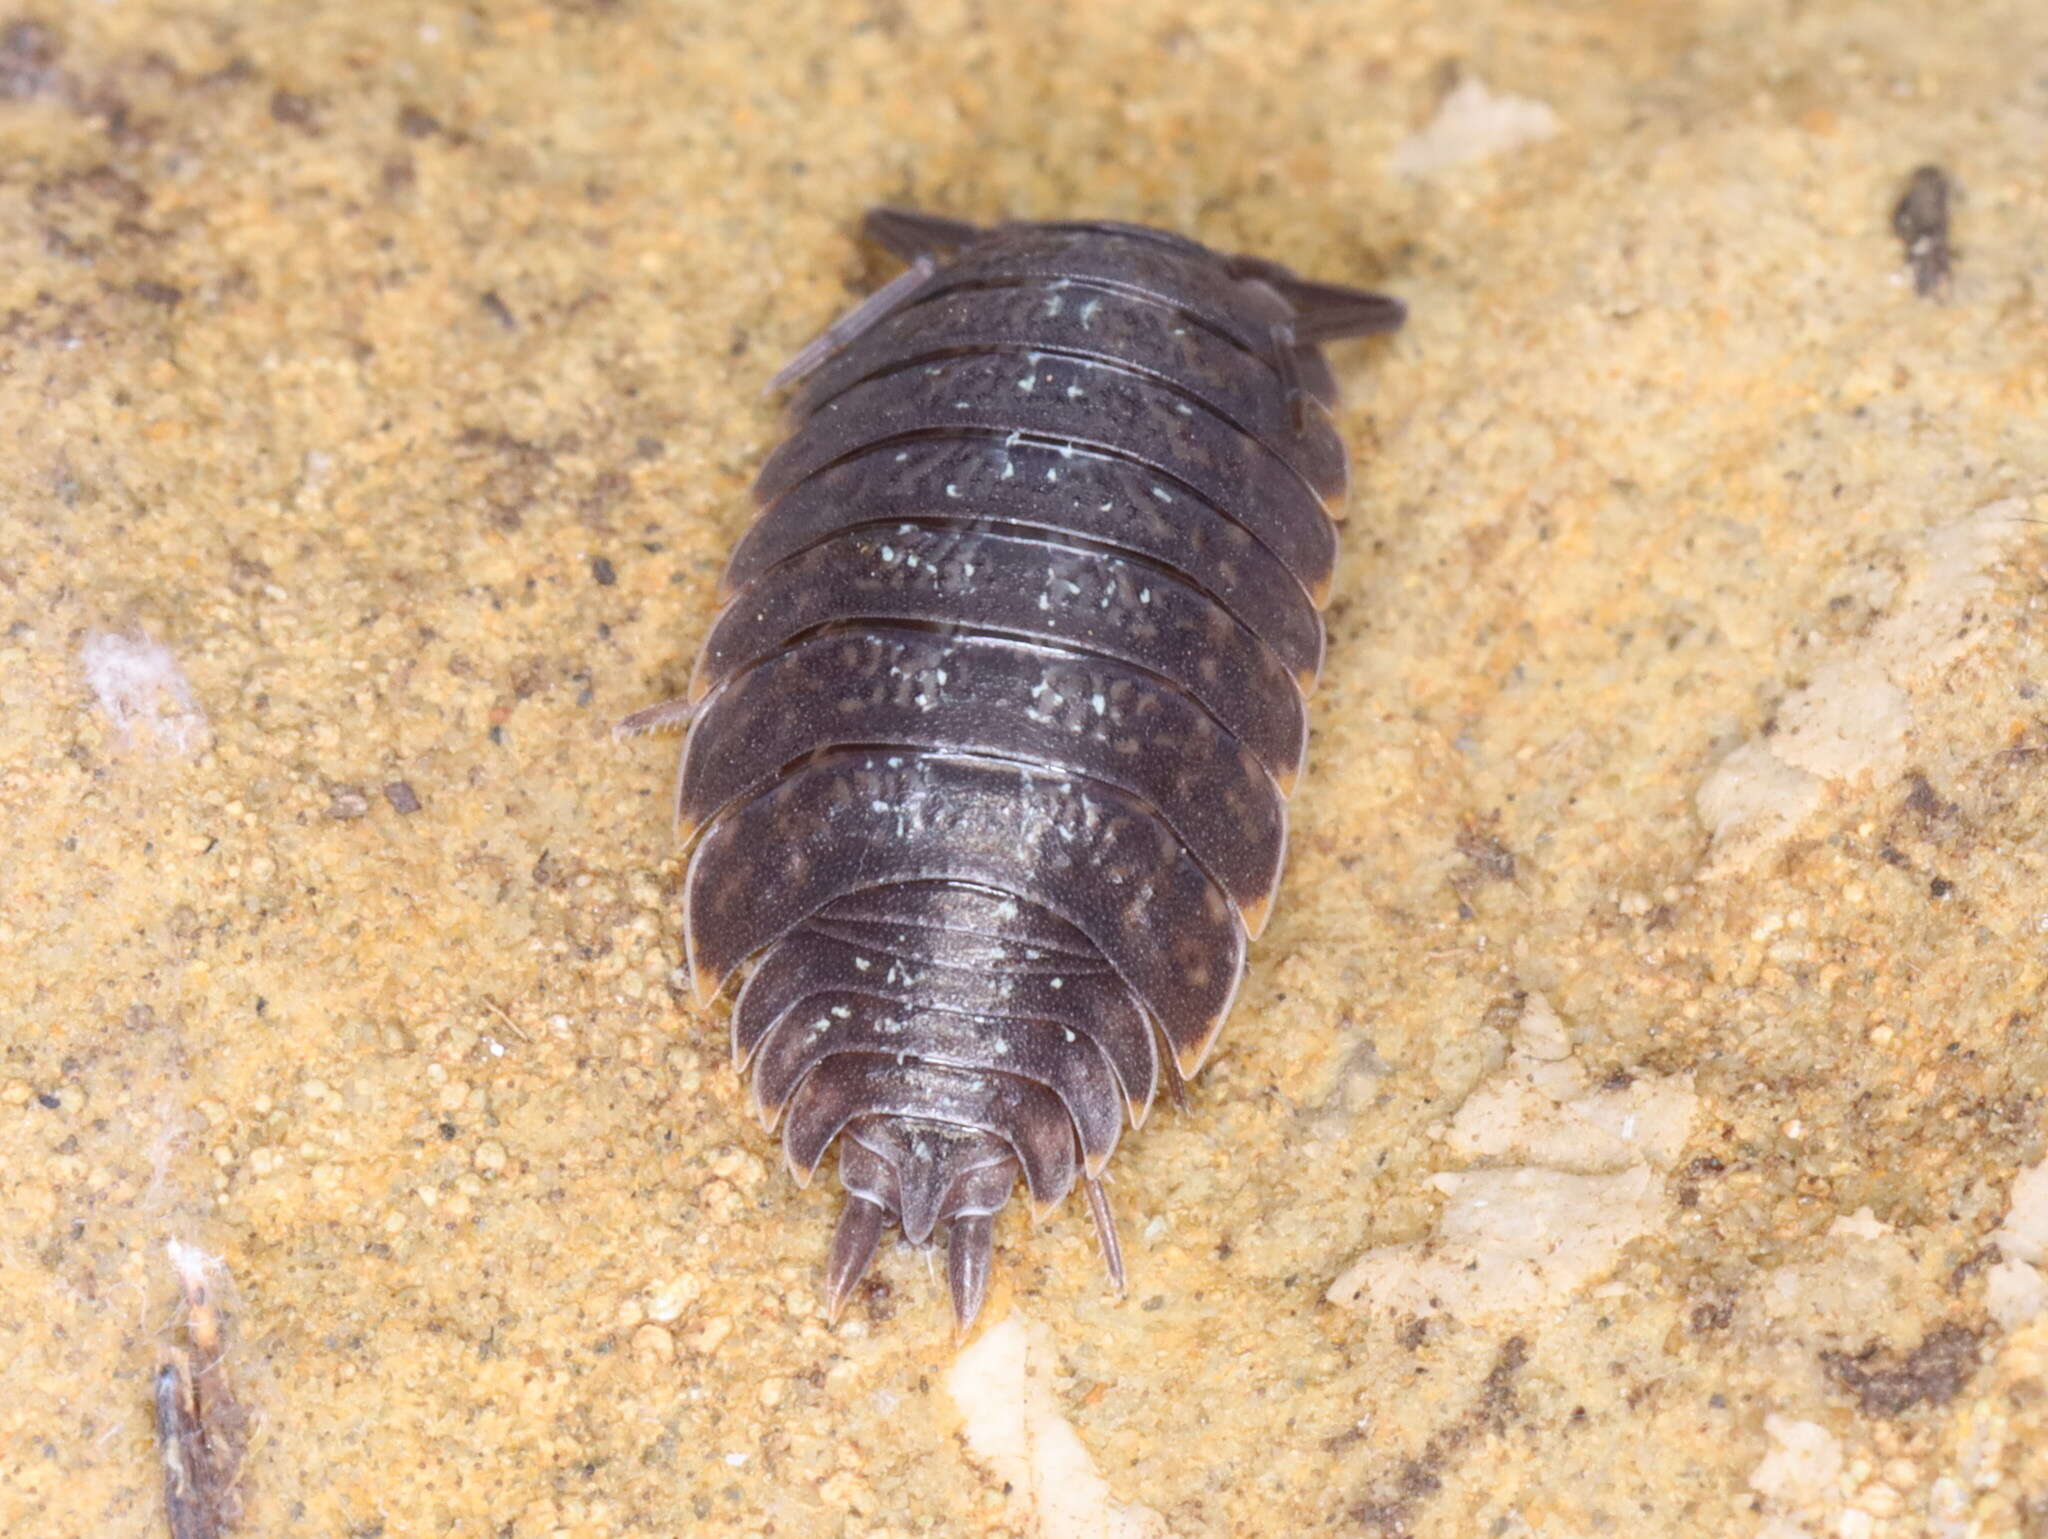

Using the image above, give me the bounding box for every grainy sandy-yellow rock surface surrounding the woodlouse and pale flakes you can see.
[0,0,2048,1539]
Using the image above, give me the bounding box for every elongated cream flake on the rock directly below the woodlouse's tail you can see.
[946,1316,1171,1539]
